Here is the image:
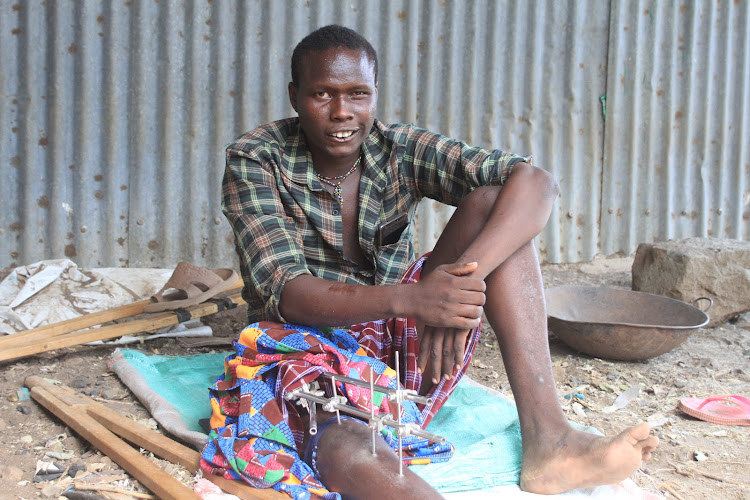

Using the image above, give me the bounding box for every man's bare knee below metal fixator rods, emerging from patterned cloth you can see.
[317,419,442,500]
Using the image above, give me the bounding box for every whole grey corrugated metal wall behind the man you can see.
[0,0,750,267]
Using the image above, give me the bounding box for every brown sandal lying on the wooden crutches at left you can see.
[143,262,239,312]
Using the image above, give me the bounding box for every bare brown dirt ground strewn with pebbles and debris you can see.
[0,258,750,499]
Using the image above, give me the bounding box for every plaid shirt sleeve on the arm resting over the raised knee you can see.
[403,127,531,206]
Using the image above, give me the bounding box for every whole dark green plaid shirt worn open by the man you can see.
[222,118,530,322]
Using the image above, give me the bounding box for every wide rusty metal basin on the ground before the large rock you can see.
[545,286,712,361]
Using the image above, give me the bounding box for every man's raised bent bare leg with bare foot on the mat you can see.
[423,188,658,494]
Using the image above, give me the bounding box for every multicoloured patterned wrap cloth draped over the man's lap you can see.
[201,258,479,499]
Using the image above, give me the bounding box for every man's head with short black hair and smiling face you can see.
[289,26,378,170]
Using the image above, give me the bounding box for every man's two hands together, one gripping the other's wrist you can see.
[415,262,485,383]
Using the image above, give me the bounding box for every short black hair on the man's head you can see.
[292,24,378,86]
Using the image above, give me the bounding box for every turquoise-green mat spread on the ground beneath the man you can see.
[113,349,536,492]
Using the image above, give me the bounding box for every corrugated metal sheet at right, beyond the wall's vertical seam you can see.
[601,0,750,250]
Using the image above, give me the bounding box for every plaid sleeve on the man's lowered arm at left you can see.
[222,149,310,322]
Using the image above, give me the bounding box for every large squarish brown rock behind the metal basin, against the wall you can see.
[632,238,750,326]
